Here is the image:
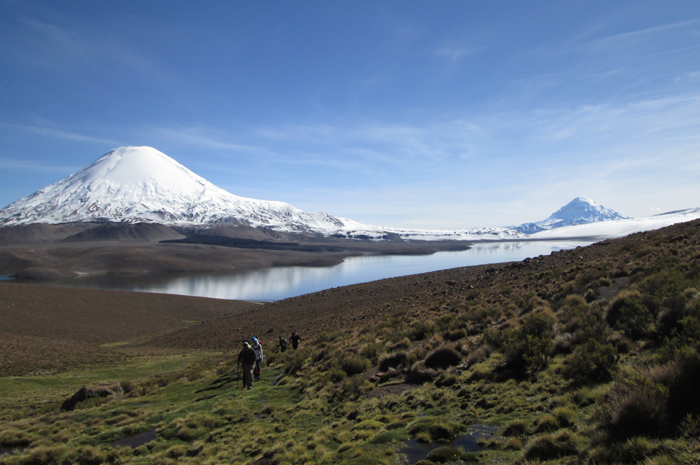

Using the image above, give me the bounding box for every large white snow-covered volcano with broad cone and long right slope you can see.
[0,147,524,240]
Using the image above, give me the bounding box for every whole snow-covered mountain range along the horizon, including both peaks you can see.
[0,147,700,242]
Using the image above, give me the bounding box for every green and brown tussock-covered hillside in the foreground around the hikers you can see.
[0,221,700,465]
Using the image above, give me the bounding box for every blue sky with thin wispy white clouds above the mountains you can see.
[0,0,700,228]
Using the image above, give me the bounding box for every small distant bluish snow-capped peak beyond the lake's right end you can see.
[513,197,630,234]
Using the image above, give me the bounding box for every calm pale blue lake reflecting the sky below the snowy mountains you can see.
[38,241,593,301]
